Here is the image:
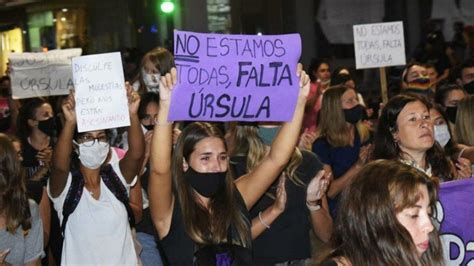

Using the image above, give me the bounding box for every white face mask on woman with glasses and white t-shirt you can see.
[78,140,110,169]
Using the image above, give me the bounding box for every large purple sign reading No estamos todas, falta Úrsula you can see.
[168,31,301,121]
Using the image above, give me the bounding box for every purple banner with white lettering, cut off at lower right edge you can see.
[436,179,474,265]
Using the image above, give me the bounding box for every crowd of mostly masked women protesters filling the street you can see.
[0,27,474,266]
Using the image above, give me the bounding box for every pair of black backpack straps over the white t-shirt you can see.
[61,164,135,236]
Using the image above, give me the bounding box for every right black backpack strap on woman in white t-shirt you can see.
[100,164,135,228]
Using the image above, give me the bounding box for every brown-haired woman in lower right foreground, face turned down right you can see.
[322,160,443,266]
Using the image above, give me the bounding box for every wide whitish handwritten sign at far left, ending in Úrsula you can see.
[8,48,82,99]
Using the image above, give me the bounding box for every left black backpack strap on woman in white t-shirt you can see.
[61,170,84,235]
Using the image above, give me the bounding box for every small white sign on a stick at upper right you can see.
[353,21,406,69]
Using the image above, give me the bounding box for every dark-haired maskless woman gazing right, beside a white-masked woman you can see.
[373,95,455,181]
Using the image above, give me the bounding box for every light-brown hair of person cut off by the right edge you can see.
[456,95,474,146]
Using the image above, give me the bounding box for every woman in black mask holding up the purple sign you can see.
[149,65,309,265]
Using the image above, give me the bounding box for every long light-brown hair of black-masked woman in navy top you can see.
[318,85,370,147]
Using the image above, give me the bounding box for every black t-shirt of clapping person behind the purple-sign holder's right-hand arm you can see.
[231,150,323,265]
